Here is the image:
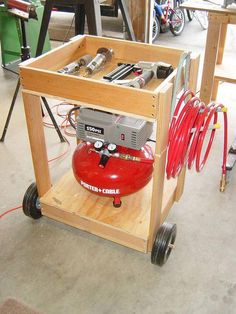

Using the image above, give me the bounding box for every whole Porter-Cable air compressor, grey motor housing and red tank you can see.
[72,107,154,207]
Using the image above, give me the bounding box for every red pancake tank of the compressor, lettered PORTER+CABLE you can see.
[72,142,153,207]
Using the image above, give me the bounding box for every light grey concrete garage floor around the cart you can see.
[0,13,236,314]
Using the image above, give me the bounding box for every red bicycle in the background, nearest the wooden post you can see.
[152,0,185,41]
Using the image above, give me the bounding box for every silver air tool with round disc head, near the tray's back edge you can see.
[85,47,114,75]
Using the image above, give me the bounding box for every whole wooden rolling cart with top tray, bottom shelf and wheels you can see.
[20,36,199,265]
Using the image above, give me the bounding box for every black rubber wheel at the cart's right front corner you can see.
[151,222,177,266]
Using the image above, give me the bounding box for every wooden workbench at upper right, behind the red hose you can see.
[181,1,236,104]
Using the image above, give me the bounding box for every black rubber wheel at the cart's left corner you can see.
[22,183,42,219]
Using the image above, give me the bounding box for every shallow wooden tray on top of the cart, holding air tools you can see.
[20,35,190,120]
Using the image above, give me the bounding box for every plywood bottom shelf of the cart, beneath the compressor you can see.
[40,171,177,252]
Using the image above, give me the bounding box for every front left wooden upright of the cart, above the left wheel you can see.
[22,92,51,197]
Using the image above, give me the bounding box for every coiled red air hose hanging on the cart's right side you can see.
[166,90,228,179]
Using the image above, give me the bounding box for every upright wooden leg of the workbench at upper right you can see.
[200,13,221,104]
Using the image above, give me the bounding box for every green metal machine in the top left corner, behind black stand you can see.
[0,0,51,67]
